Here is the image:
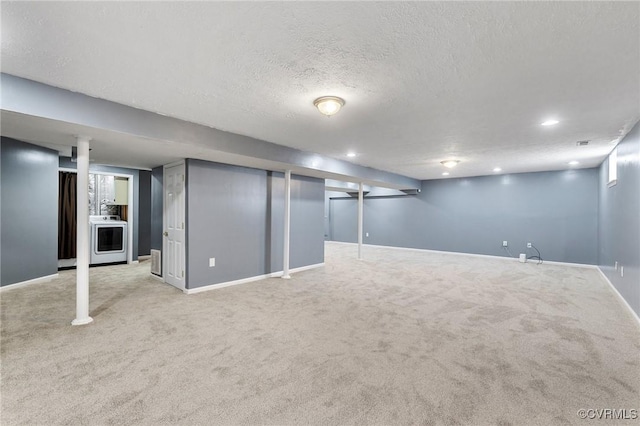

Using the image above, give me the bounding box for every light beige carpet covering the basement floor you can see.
[0,243,640,426]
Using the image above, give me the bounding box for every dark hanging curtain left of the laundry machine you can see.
[58,172,78,259]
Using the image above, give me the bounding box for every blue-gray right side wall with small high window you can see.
[598,123,640,315]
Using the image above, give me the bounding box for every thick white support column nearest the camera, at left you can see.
[71,136,93,325]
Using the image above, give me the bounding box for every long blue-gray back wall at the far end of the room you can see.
[330,169,598,264]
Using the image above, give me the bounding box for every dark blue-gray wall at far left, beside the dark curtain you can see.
[0,137,58,286]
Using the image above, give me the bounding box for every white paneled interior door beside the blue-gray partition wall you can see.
[162,163,186,290]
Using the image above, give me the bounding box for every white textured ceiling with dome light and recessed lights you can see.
[1,1,640,179]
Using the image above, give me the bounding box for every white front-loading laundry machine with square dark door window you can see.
[89,215,129,265]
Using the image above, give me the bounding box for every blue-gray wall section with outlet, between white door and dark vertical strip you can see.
[187,159,270,289]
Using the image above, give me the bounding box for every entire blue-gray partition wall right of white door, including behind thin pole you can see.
[187,159,324,289]
